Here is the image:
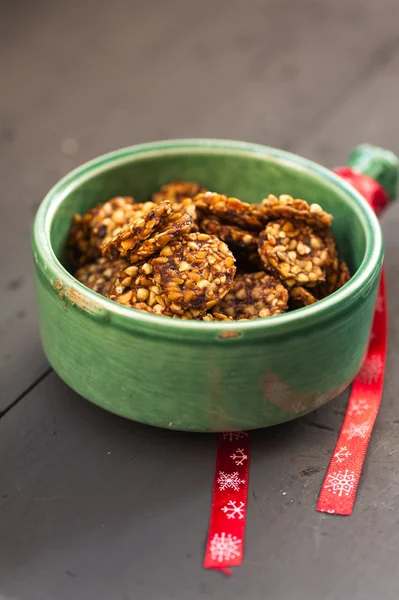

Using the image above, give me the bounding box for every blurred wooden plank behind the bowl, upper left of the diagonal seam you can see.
[0,0,398,411]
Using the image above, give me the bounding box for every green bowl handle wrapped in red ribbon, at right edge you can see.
[334,144,399,214]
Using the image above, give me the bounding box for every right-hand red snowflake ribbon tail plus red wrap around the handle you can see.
[317,167,388,515]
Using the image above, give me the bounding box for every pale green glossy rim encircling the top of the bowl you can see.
[32,138,383,339]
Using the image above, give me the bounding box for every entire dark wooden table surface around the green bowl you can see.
[0,0,399,600]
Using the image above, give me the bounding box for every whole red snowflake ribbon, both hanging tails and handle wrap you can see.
[204,167,388,575]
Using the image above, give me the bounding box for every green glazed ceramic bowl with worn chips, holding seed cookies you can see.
[33,140,383,432]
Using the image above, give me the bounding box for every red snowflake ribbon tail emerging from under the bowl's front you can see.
[204,431,249,575]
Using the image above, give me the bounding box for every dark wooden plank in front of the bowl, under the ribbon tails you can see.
[0,358,399,600]
